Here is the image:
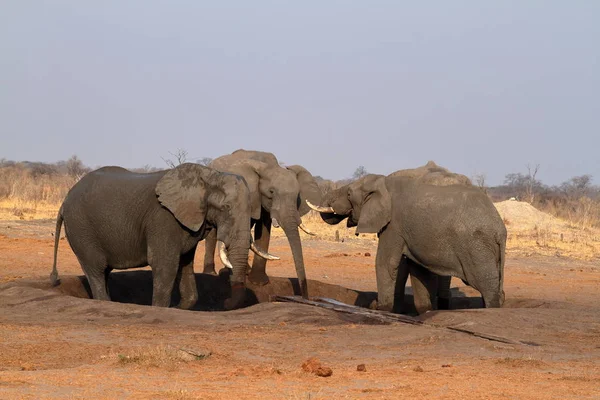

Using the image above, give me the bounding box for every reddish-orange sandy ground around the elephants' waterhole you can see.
[0,221,600,399]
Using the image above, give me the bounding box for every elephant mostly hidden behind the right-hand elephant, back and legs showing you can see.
[389,161,473,313]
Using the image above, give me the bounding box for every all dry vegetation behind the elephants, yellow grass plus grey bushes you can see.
[0,156,600,260]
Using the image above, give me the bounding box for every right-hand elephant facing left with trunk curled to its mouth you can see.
[309,174,506,313]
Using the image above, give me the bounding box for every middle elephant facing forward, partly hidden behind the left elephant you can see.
[204,149,322,298]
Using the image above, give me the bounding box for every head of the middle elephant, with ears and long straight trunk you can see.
[226,159,321,298]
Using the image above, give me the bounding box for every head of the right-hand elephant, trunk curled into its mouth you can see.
[307,174,392,235]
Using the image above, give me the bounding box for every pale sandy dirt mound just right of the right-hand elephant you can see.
[494,200,566,230]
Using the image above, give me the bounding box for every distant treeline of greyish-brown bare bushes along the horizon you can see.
[0,158,600,228]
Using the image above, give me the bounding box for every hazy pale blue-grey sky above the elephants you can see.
[0,0,600,185]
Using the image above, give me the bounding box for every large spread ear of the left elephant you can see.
[155,163,213,232]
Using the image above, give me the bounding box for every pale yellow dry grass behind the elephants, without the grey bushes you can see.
[0,166,600,260]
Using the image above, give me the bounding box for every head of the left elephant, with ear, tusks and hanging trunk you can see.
[155,163,274,308]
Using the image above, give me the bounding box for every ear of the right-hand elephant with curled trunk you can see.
[356,175,392,234]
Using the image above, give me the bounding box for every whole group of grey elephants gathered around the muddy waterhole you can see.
[50,150,506,313]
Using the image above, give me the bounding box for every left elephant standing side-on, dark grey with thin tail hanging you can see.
[50,163,271,309]
